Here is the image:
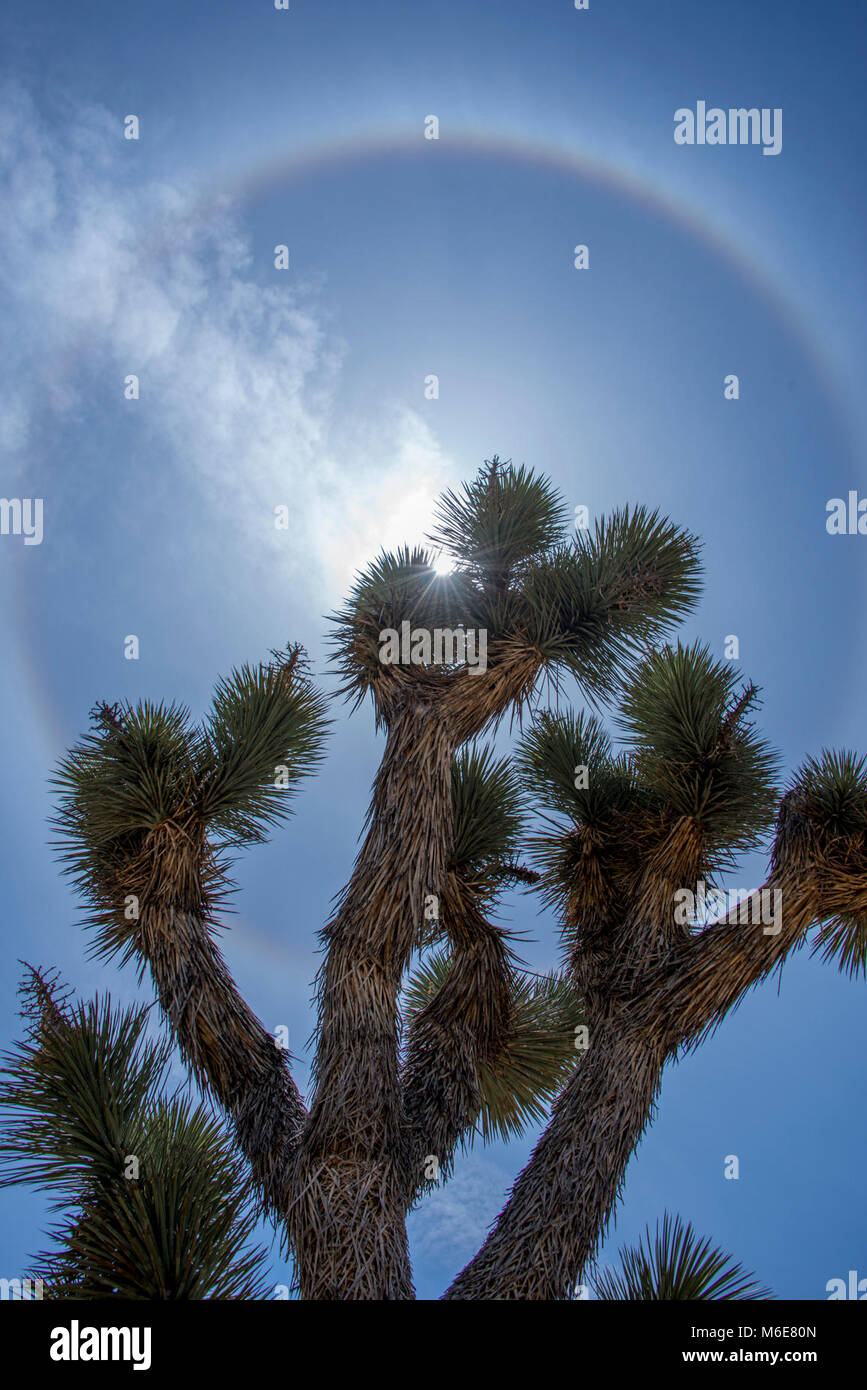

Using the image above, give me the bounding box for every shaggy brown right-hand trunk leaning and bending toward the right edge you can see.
[443,798,867,1300]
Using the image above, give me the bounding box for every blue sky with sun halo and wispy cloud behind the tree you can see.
[0,0,867,1298]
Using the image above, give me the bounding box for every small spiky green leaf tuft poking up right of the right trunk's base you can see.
[592,1212,774,1302]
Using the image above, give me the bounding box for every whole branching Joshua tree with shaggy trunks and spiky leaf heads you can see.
[11,457,867,1298]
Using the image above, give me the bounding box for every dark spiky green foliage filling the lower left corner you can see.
[0,972,267,1300]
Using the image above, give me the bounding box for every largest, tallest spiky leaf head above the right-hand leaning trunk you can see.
[620,642,778,863]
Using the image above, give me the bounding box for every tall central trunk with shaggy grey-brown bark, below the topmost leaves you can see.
[288,696,454,1300]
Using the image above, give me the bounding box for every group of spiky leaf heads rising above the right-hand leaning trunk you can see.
[518,645,777,948]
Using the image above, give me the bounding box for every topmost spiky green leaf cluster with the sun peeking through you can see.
[327,459,700,709]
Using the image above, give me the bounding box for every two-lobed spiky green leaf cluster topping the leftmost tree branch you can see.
[53,646,329,954]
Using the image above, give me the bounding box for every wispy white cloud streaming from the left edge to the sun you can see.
[0,74,450,600]
